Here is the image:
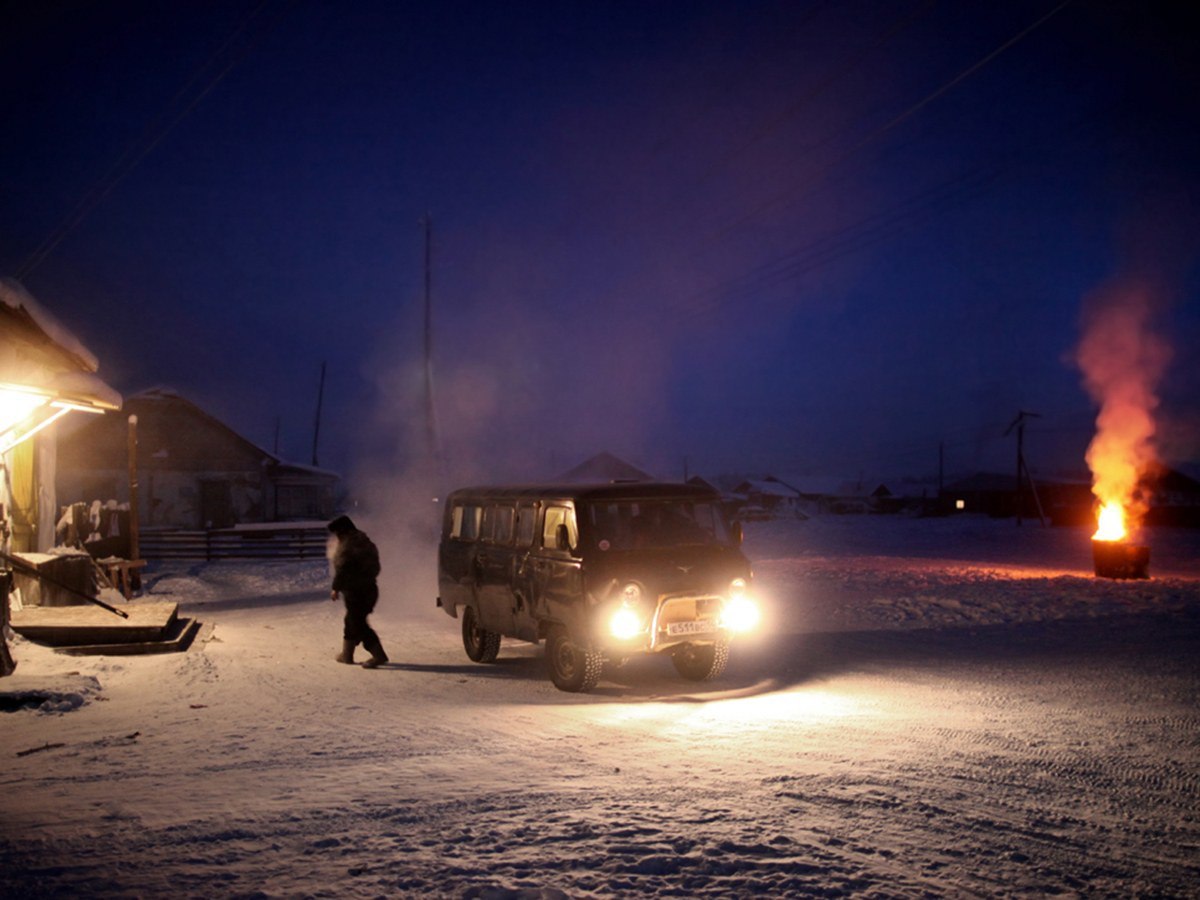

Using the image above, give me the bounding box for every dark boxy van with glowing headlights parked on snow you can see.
[437,482,758,691]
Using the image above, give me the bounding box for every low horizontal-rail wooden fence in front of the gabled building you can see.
[138,524,329,560]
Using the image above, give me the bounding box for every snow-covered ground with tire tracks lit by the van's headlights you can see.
[0,517,1200,898]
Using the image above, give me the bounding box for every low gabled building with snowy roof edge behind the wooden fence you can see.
[58,390,340,529]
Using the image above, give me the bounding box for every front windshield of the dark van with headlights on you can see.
[580,499,730,550]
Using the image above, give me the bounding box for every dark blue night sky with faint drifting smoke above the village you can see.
[0,0,1200,494]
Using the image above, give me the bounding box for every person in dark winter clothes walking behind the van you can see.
[329,516,388,668]
